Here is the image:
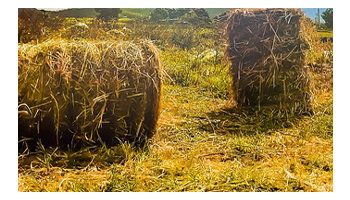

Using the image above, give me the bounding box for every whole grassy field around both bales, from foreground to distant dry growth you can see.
[18,10,333,192]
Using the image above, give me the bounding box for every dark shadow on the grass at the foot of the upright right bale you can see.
[197,107,309,136]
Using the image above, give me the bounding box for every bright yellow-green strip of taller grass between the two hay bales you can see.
[162,48,231,98]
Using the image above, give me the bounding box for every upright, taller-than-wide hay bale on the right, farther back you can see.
[225,9,312,113]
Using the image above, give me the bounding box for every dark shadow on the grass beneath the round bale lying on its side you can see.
[18,141,149,171]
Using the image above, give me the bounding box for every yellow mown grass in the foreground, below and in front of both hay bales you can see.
[18,72,333,191]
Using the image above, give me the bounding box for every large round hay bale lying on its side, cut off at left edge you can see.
[18,40,161,148]
